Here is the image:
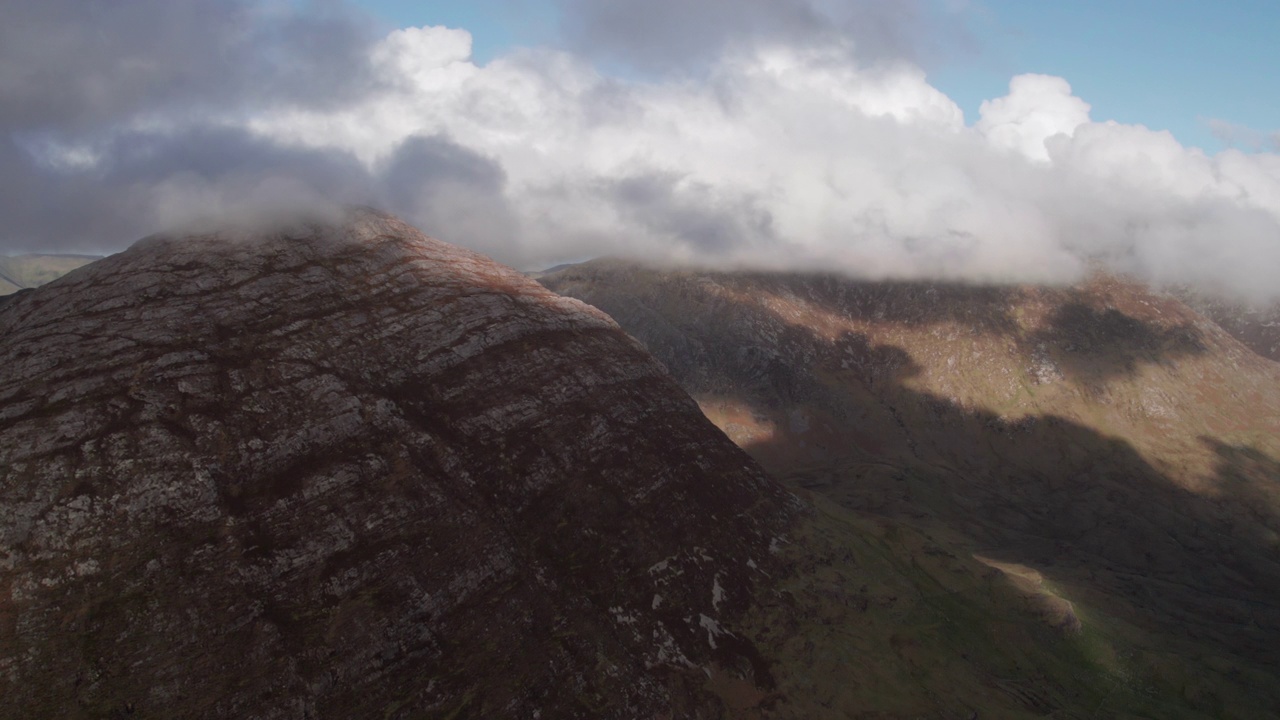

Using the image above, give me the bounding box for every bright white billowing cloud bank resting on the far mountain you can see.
[253,28,1280,297]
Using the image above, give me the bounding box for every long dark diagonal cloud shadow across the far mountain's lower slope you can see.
[740,336,1280,696]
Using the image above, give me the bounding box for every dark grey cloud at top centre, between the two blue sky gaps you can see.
[561,0,929,70]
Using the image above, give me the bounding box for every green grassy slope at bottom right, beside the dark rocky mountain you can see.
[742,495,1274,720]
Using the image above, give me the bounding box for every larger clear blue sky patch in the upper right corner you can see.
[932,0,1280,151]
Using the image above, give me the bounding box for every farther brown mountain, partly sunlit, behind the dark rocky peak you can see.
[541,260,1280,717]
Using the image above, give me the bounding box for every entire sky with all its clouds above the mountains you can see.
[0,0,1280,302]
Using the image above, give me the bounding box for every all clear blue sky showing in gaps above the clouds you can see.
[357,0,1280,152]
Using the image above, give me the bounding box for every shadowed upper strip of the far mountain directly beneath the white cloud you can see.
[540,260,1208,392]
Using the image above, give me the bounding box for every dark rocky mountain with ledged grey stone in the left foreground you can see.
[0,211,797,719]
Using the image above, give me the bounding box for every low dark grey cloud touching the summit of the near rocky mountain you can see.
[0,126,535,254]
